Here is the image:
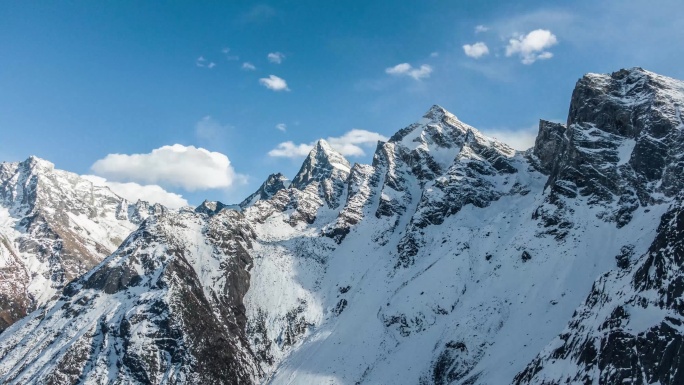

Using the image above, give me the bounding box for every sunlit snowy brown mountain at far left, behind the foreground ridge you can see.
[0,157,165,331]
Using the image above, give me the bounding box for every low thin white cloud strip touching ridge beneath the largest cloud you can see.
[82,175,188,209]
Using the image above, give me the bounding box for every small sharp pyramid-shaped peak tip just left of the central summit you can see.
[291,139,351,208]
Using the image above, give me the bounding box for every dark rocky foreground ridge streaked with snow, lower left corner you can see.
[0,210,260,384]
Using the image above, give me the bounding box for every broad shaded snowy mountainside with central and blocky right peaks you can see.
[240,69,684,384]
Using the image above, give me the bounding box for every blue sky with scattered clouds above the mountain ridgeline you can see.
[0,1,684,205]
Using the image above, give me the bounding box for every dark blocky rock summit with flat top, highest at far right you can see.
[548,68,684,226]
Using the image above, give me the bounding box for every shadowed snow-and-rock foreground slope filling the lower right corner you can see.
[515,194,684,384]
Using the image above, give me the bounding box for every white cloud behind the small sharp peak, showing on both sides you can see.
[268,128,388,158]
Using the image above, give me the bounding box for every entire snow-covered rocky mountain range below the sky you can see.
[0,68,684,385]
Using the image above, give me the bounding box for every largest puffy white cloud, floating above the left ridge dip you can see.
[90,144,244,191]
